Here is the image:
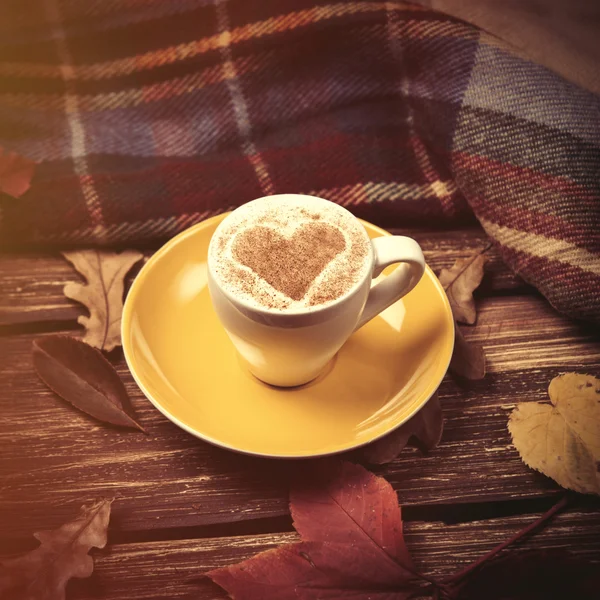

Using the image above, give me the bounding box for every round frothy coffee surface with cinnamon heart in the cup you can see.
[209,197,371,312]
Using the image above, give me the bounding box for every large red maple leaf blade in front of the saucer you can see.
[208,463,419,600]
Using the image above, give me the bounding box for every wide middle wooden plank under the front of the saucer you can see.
[0,296,600,539]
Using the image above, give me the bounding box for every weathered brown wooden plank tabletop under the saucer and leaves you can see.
[0,227,600,600]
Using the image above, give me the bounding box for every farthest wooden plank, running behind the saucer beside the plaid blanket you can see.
[0,228,524,325]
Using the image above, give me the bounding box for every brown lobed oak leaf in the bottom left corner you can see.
[0,499,112,600]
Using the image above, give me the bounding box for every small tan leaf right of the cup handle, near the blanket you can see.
[439,253,486,325]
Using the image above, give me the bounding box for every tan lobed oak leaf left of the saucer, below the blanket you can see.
[63,250,143,351]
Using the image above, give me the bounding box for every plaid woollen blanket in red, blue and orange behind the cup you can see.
[0,0,600,322]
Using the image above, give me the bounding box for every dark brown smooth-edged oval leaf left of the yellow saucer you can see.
[33,335,145,433]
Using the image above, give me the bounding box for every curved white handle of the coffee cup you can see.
[355,235,425,331]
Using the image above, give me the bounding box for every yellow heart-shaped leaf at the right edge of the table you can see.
[508,373,600,495]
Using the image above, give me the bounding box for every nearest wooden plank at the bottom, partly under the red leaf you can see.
[58,511,600,600]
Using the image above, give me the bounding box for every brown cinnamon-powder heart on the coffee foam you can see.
[232,223,346,301]
